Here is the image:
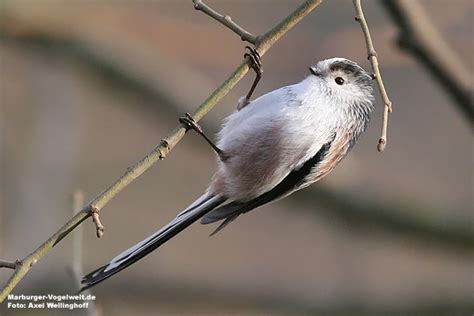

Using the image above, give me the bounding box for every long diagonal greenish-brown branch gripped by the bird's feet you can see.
[0,0,321,302]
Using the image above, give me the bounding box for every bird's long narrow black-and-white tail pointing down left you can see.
[80,194,226,292]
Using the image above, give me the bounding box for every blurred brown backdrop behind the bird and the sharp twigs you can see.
[0,0,474,315]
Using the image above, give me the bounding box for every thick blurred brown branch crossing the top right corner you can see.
[382,0,474,124]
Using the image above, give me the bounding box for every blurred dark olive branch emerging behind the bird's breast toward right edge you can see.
[298,186,474,252]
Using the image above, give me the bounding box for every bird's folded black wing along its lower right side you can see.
[201,136,335,235]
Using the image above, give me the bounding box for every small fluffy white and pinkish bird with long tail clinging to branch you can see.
[81,47,374,291]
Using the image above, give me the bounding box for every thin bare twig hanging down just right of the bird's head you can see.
[353,0,392,152]
